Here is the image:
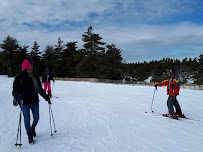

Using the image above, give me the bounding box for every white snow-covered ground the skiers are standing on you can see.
[0,76,203,152]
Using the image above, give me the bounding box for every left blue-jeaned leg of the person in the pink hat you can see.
[20,105,31,133]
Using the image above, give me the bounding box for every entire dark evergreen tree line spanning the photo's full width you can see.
[0,26,203,84]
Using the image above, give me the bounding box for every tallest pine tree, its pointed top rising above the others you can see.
[76,25,105,78]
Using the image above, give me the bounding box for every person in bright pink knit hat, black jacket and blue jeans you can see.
[12,60,51,143]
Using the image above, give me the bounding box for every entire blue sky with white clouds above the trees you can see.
[0,0,203,62]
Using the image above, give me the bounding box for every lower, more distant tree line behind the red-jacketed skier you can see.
[124,54,203,84]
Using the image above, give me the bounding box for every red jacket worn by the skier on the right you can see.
[157,76,181,96]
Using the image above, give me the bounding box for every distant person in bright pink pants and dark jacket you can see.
[42,69,54,97]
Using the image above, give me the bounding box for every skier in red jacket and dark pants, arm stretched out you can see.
[154,68,185,119]
